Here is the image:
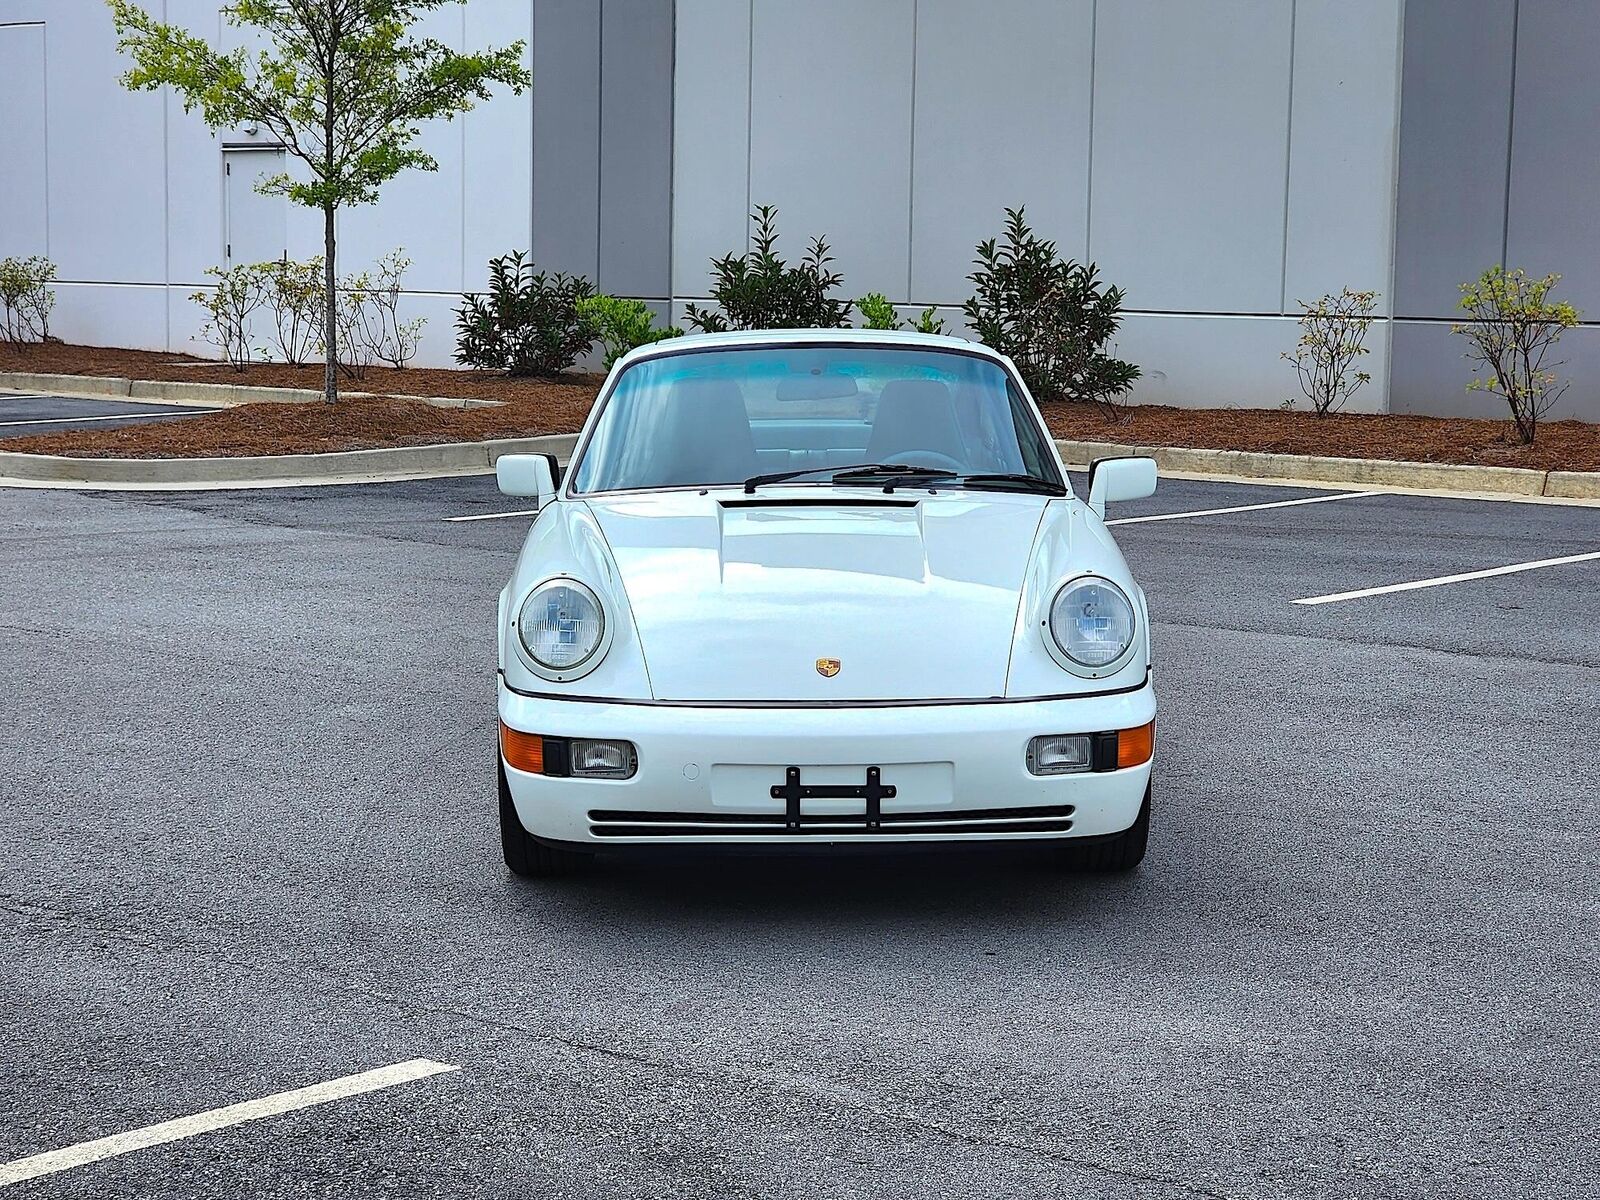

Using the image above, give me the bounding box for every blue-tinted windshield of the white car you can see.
[573,346,1061,493]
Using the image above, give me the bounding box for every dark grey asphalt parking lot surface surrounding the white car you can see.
[0,473,1600,1200]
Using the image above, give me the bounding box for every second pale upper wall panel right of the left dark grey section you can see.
[745,0,914,296]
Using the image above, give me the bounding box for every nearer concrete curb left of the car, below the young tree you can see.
[0,434,578,491]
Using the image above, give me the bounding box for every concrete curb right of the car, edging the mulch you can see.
[1056,440,1600,499]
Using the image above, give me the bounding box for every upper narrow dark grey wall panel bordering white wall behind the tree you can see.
[533,0,600,278]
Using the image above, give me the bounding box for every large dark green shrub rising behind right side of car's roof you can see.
[962,208,1139,410]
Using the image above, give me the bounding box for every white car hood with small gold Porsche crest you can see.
[587,488,1048,701]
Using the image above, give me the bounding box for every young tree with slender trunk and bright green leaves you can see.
[107,0,531,403]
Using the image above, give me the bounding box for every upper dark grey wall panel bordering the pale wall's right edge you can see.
[1394,0,1515,320]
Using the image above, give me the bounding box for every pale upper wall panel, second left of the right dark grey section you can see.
[1090,0,1293,314]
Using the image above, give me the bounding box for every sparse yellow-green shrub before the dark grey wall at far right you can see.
[1450,266,1578,445]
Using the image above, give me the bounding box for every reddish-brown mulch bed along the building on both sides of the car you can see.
[0,344,1600,470]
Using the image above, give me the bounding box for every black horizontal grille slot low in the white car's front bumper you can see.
[589,805,1072,837]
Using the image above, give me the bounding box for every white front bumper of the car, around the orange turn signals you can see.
[499,680,1155,848]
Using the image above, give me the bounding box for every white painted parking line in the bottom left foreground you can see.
[0,1058,461,1187]
